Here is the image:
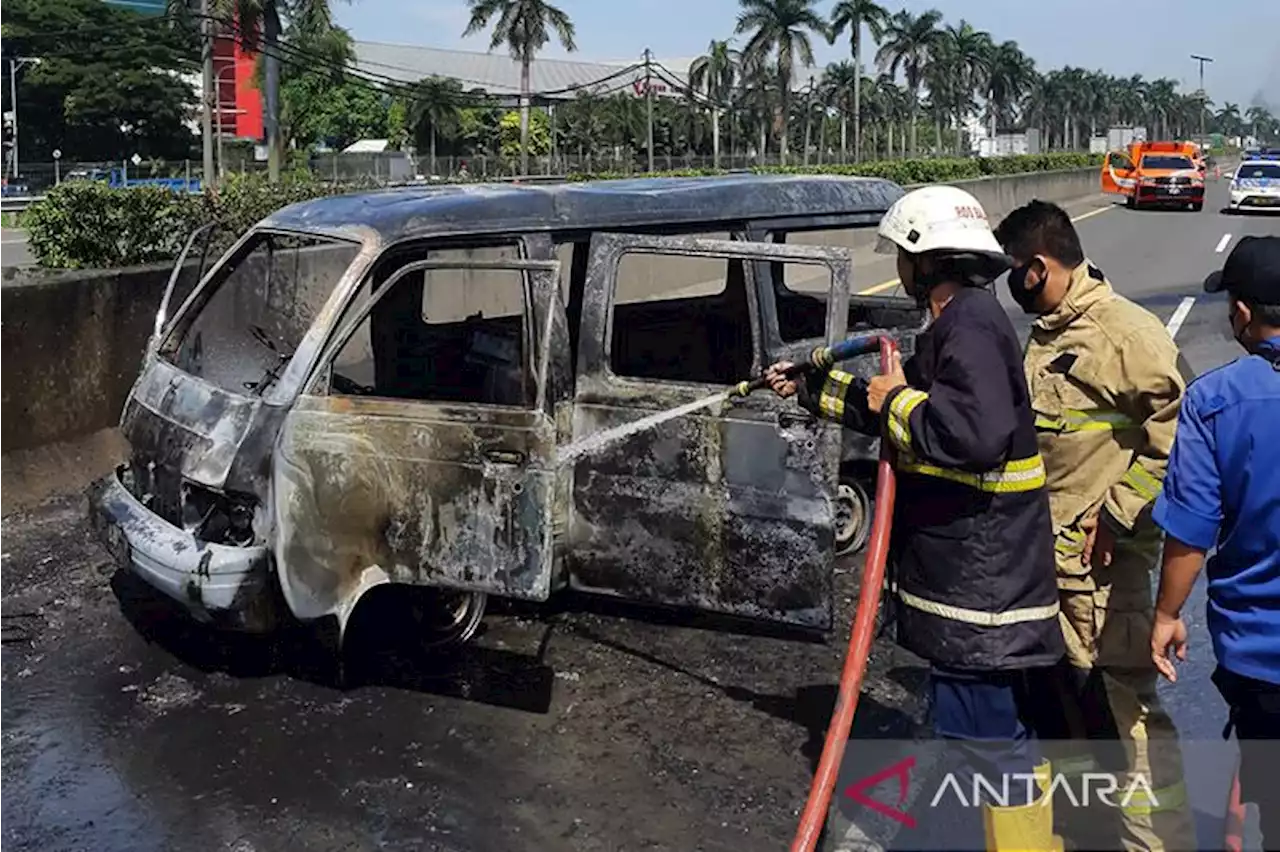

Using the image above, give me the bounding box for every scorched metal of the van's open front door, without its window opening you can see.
[273,241,563,623]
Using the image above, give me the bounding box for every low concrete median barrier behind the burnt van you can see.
[0,169,1098,514]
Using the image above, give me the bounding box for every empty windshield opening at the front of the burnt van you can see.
[160,232,361,395]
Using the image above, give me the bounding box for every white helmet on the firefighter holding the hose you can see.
[876,185,1009,265]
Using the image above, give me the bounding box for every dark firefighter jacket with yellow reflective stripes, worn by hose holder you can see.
[801,289,1064,670]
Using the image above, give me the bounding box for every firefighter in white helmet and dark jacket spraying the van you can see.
[767,187,1062,849]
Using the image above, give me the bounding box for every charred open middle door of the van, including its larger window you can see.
[567,228,852,629]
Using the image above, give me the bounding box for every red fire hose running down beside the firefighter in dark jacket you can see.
[791,336,897,852]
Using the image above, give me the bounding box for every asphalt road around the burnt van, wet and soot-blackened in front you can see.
[0,184,1280,852]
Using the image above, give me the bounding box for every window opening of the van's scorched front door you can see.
[329,246,536,408]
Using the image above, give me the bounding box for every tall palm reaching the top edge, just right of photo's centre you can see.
[733,0,827,165]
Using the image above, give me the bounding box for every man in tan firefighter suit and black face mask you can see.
[996,201,1196,849]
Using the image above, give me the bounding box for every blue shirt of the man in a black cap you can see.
[1153,338,1280,684]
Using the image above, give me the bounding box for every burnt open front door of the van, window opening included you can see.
[273,246,564,619]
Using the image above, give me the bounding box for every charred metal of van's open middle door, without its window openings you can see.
[568,233,852,631]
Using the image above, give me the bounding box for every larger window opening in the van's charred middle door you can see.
[609,241,755,385]
